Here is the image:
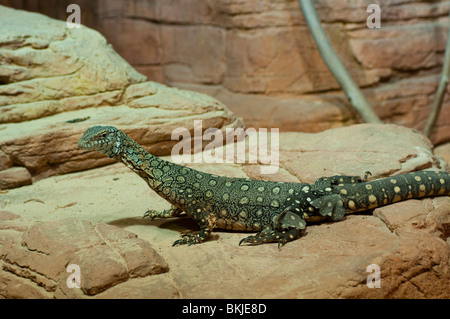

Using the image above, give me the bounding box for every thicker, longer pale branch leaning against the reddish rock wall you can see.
[298,0,382,123]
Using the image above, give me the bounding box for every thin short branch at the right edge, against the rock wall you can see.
[423,9,450,137]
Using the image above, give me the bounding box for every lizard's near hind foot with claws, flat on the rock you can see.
[239,228,304,249]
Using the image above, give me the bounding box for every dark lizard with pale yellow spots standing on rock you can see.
[78,126,450,245]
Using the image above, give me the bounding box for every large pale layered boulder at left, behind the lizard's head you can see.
[0,6,244,188]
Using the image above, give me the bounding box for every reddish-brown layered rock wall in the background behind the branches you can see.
[0,0,450,144]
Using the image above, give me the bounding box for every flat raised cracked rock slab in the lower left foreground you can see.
[2,219,168,296]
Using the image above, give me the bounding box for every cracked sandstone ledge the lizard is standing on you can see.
[0,125,450,298]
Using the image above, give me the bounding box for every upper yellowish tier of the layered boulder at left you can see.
[0,7,145,123]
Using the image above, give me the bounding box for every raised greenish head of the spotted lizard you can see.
[78,126,123,157]
